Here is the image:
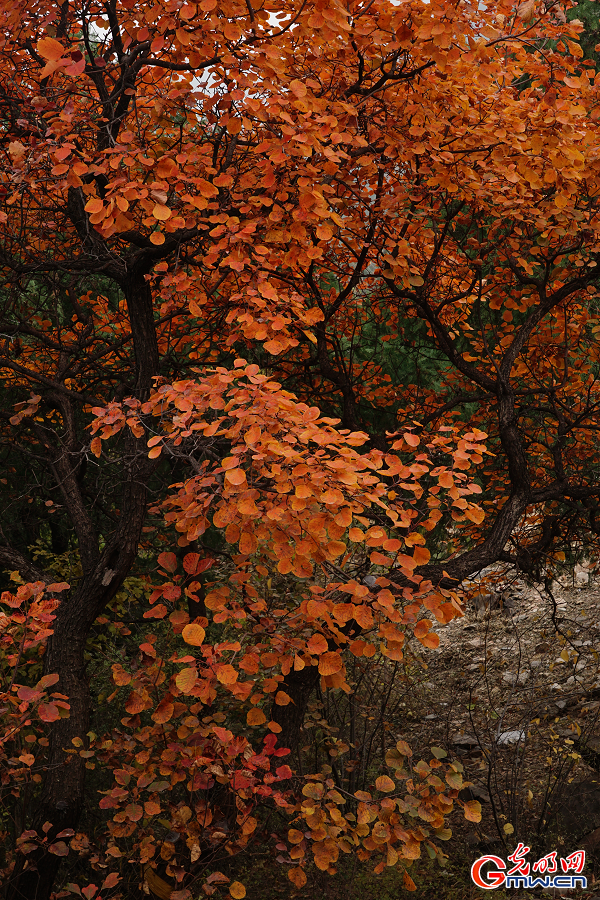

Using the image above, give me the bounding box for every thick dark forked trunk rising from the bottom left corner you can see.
[6,263,159,900]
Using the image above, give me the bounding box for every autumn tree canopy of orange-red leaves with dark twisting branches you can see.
[0,0,599,900]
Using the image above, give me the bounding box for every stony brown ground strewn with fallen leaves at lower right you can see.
[401,571,600,900]
